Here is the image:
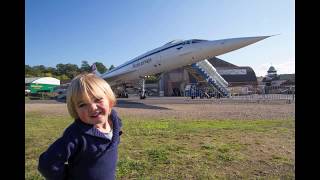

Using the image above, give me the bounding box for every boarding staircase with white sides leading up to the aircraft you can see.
[185,59,230,97]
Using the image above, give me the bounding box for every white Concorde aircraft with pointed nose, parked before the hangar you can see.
[92,36,270,99]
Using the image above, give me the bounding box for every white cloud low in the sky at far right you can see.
[253,60,295,76]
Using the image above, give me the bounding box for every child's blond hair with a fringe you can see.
[67,73,116,119]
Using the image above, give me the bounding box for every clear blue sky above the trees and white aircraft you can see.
[25,0,295,76]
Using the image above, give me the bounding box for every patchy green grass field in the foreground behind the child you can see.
[25,113,295,179]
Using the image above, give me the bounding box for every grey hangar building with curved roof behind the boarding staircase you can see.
[159,57,258,96]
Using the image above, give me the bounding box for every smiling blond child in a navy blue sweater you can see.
[38,73,122,180]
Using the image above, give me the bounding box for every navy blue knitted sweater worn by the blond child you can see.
[38,110,122,180]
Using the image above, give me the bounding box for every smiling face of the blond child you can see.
[75,97,111,125]
